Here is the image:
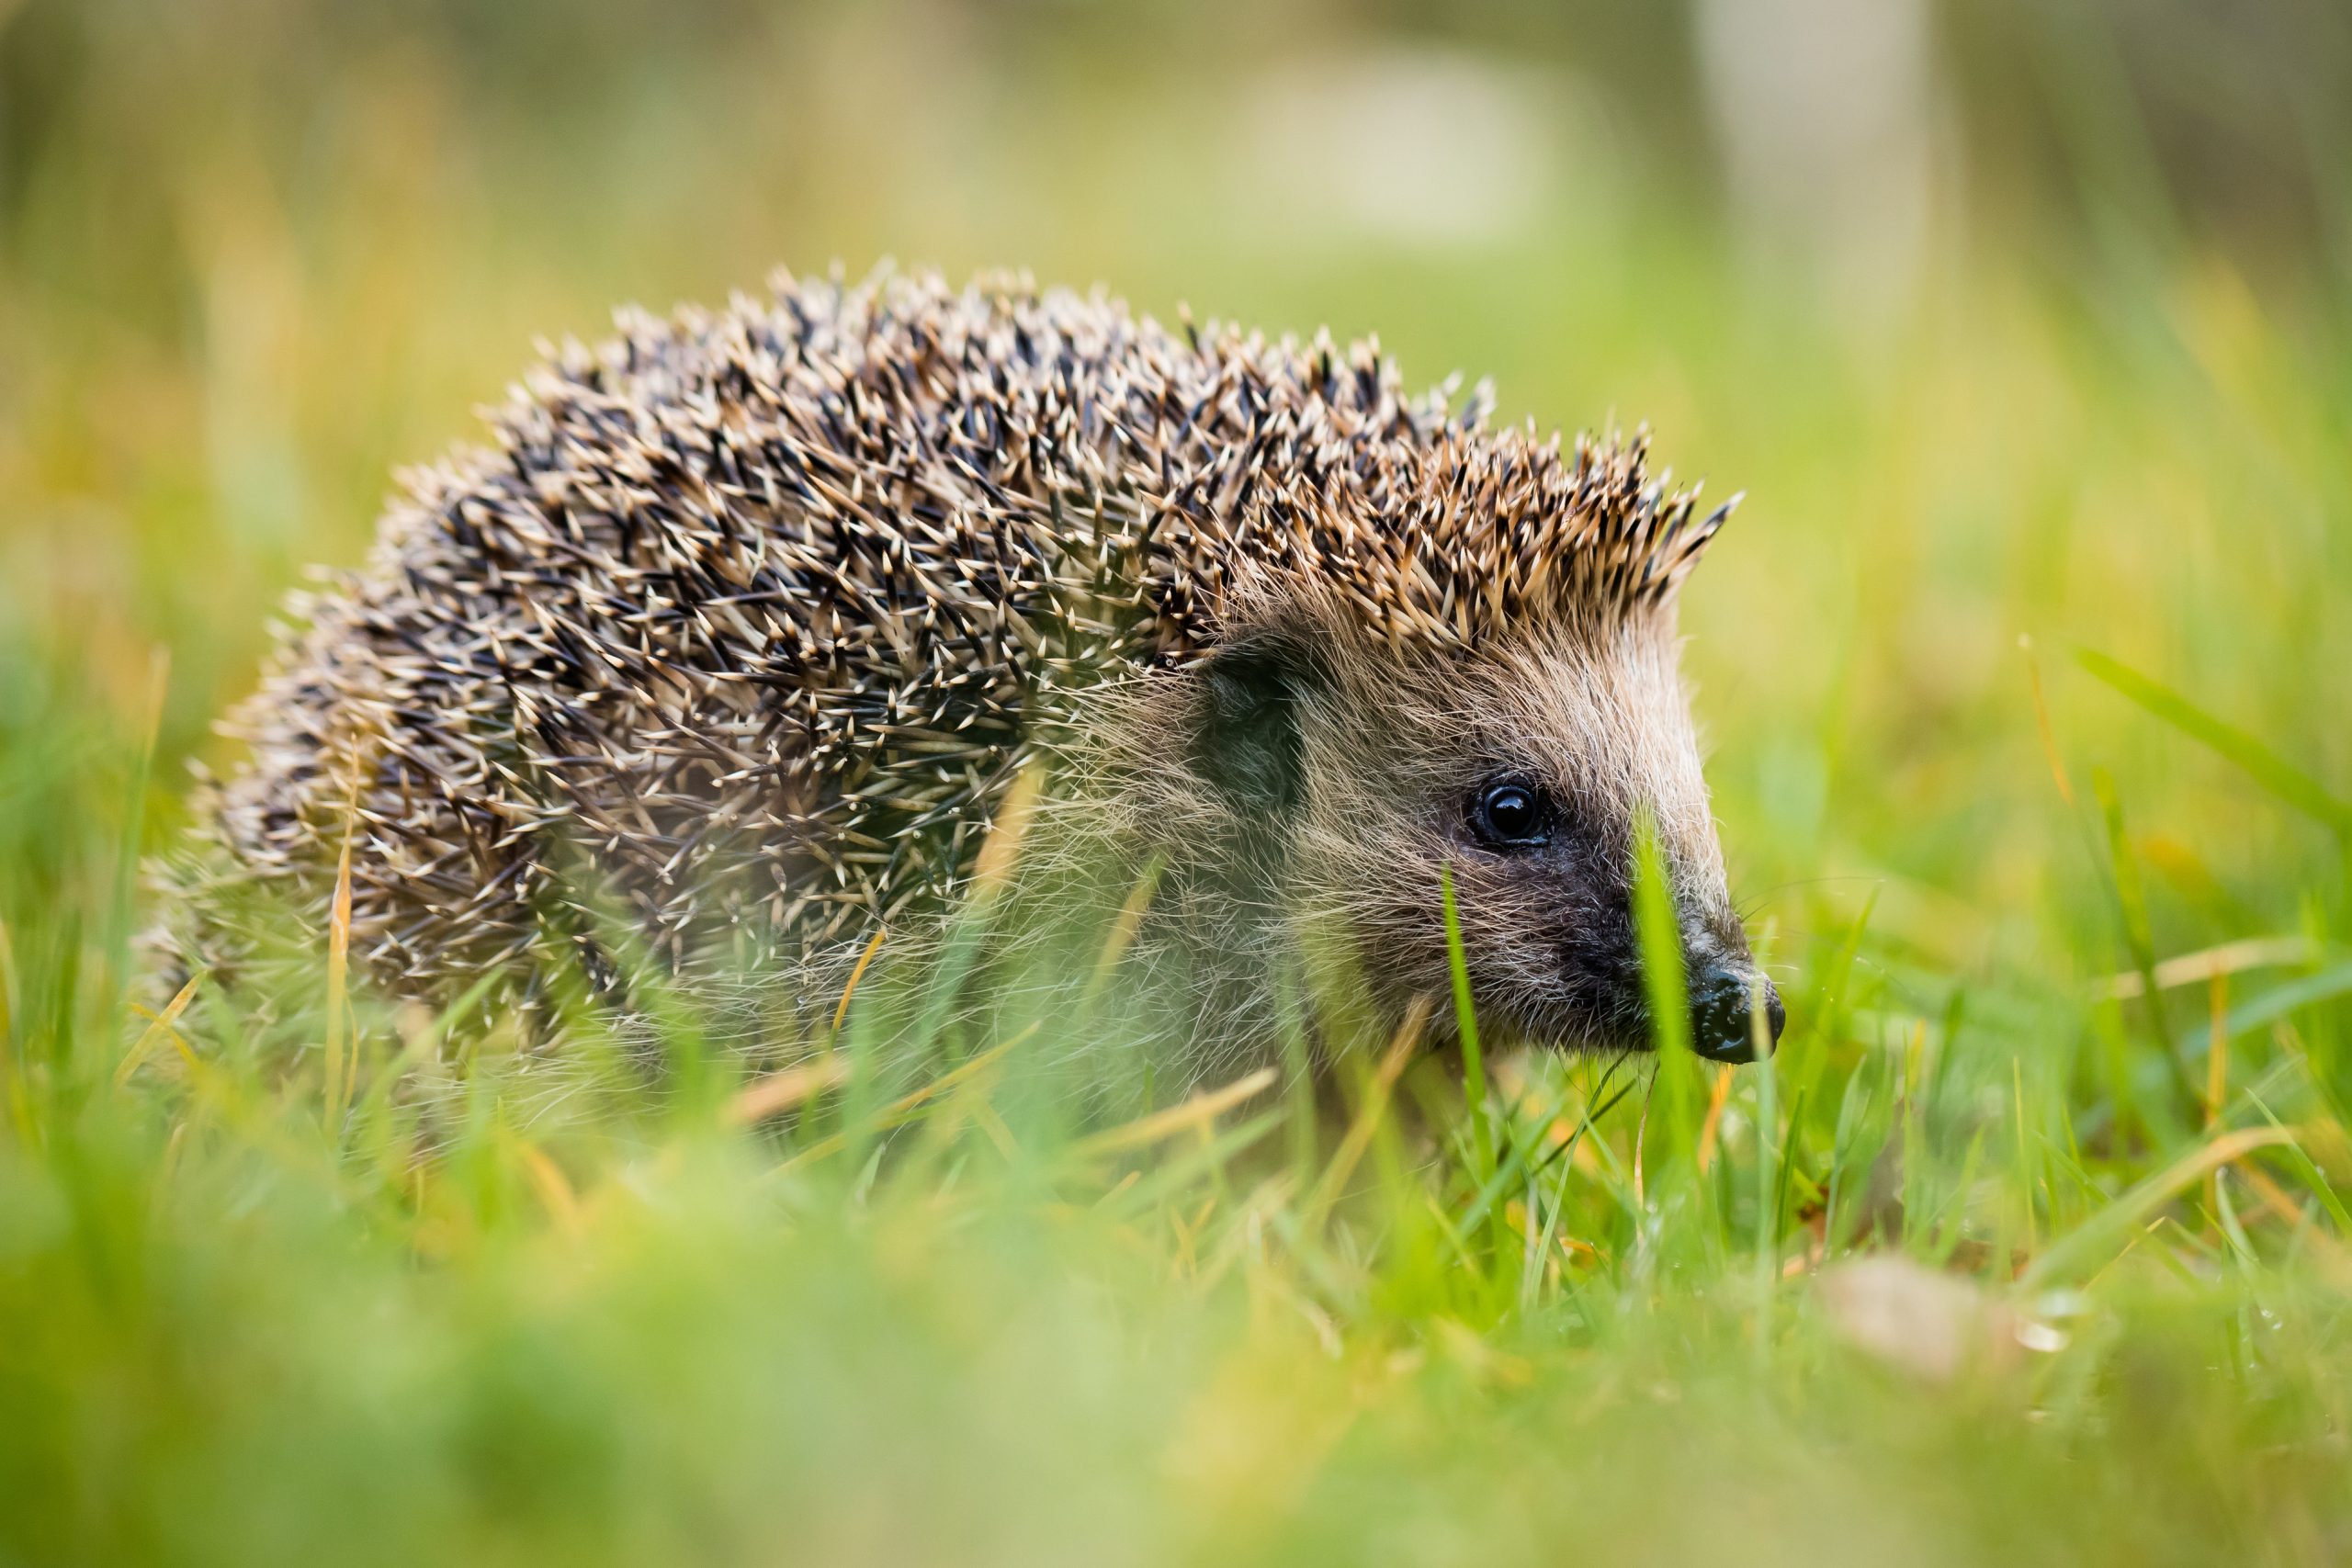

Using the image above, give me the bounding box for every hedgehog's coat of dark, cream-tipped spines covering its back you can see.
[156,266,1714,992]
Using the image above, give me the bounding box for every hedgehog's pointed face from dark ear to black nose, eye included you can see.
[1202,611,1781,1060]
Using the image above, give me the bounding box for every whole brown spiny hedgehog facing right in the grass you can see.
[163,273,1782,1081]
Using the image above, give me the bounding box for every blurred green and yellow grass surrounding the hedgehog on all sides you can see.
[0,0,2352,1563]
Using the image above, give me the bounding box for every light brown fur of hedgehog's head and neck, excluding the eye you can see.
[1058,582,1778,1060]
